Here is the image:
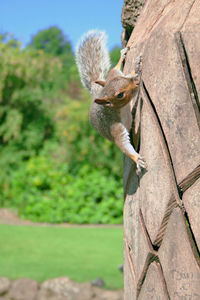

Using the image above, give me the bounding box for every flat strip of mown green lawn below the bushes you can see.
[0,225,123,289]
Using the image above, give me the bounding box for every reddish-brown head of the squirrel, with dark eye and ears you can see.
[94,76,139,108]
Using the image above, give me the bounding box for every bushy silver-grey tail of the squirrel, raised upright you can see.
[76,30,110,92]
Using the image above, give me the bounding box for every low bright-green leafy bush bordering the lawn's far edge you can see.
[4,157,123,223]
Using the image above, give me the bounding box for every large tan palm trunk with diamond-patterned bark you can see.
[124,0,200,300]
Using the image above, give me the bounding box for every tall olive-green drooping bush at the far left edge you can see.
[0,34,59,157]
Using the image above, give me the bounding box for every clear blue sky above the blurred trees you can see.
[0,0,124,49]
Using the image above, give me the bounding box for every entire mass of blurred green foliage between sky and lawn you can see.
[0,27,123,223]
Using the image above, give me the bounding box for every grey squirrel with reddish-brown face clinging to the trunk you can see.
[75,30,146,172]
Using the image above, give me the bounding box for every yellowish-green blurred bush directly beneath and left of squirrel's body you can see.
[55,99,122,179]
